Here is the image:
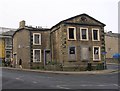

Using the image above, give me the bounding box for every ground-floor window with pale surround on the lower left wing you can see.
[33,49,41,62]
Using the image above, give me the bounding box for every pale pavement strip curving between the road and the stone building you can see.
[2,67,120,75]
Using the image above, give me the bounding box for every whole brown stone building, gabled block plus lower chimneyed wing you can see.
[13,14,105,70]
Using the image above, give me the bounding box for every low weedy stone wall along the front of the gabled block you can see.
[32,63,105,71]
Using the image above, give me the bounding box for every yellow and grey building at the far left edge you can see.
[0,27,15,66]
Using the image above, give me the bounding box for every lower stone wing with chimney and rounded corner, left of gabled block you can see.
[13,21,51,69]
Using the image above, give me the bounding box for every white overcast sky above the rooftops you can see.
[0,0,119,33]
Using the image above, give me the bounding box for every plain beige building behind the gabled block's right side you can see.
[105,31,120,62]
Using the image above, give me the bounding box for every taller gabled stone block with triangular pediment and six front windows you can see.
[51,14,105,69]
